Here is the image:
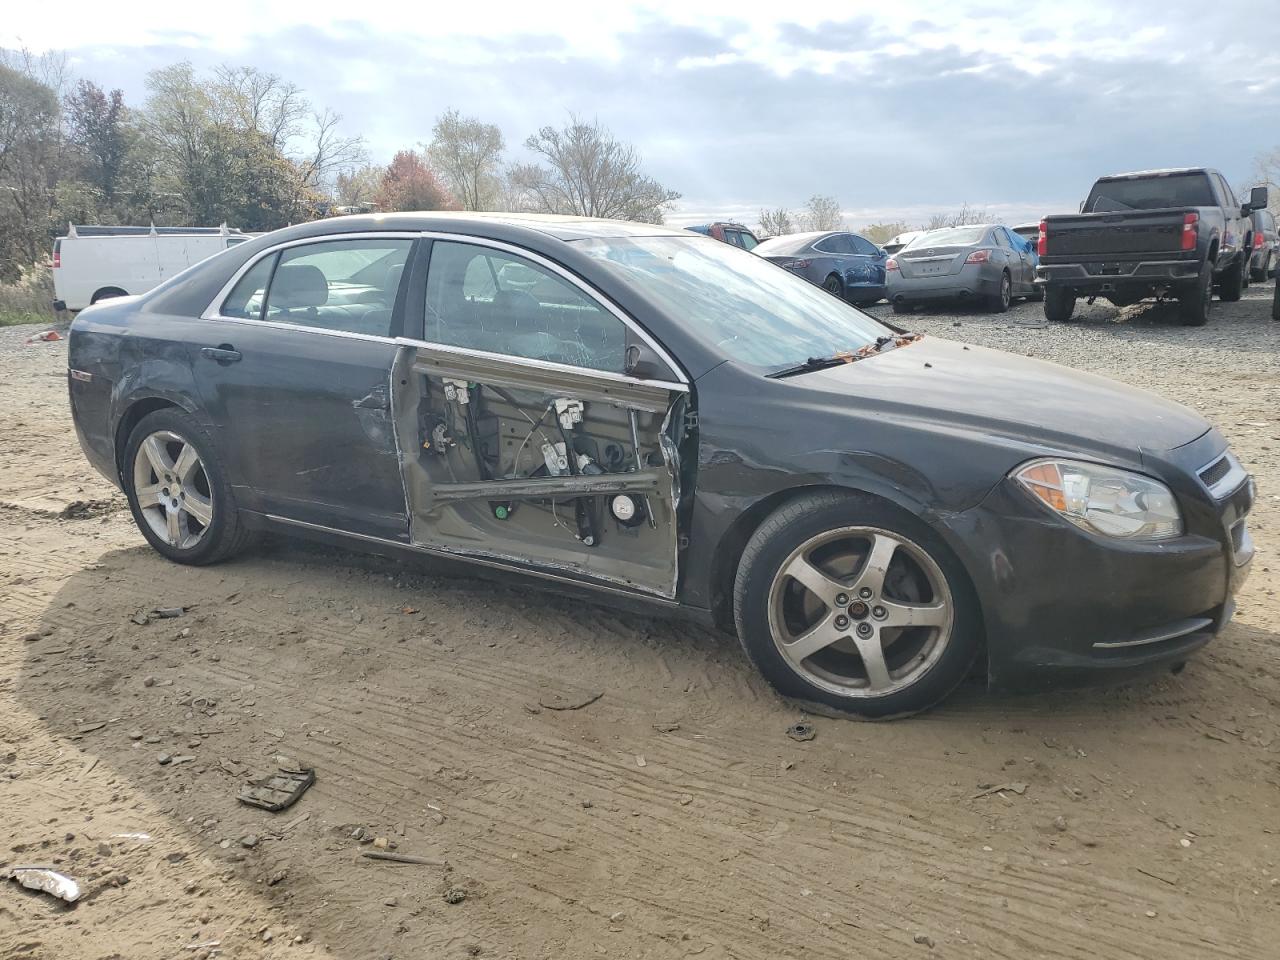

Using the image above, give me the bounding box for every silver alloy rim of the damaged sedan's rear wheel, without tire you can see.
[133,430,214,550]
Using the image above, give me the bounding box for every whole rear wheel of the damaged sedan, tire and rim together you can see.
[122,408,250,566]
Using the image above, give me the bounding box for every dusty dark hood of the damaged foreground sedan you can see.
[785,337,1210,457]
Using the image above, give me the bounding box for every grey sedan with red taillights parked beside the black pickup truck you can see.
[886,224,1037,314]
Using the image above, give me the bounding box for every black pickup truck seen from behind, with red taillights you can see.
[1036,166,1267,326]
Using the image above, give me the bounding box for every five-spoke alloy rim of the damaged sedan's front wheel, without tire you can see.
[769,526,955,698]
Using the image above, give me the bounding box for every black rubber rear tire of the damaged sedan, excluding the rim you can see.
[120,408,252,566]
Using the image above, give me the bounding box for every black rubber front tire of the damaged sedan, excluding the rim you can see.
[733,492,982,718]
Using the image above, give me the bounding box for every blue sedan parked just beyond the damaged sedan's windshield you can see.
[755,230,888,305]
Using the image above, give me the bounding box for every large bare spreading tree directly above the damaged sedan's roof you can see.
[511,115,680,223]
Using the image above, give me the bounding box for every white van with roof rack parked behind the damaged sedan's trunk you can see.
[54,224,250,310]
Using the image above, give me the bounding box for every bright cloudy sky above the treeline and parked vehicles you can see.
[0,0,1280,227]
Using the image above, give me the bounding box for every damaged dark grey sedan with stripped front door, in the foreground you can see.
[68,212,1253,717]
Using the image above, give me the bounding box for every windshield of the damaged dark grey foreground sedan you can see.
[576,237,892,371]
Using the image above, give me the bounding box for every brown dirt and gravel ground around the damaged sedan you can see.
[0,287,1280,960]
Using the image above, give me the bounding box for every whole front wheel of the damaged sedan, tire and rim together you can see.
[733,492,980,718]
